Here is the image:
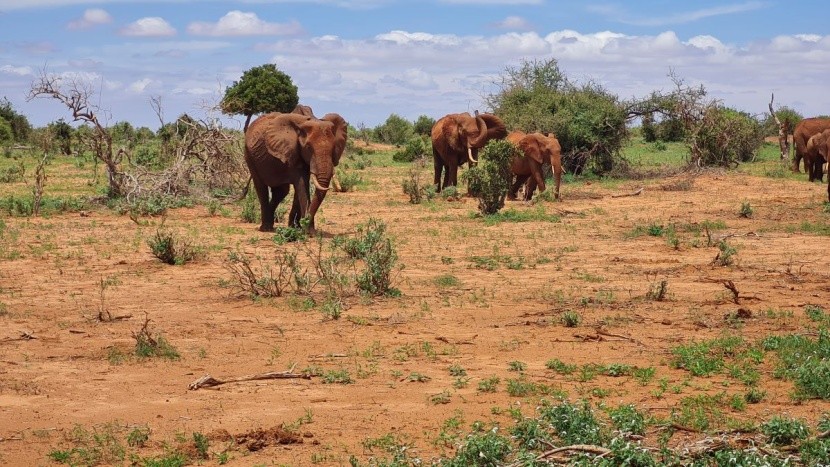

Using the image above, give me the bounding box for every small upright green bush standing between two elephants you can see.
[464,140,518,215]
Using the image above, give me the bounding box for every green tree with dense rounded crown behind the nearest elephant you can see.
[219,63,300,131]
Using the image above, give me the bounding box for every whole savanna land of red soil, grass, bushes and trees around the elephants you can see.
[0,61,830,466]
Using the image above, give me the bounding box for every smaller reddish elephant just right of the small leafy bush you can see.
[507,131,562,201]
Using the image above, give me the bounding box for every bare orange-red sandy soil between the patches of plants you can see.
[0,163,830,465]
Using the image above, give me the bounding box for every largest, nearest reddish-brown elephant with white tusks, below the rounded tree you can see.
[245,113,347,232]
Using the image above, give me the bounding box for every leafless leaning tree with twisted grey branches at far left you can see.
[27,69,129,198]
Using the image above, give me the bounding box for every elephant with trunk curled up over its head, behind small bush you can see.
[432,111,507,191]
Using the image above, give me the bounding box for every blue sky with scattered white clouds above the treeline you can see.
[0,0,830,129]
